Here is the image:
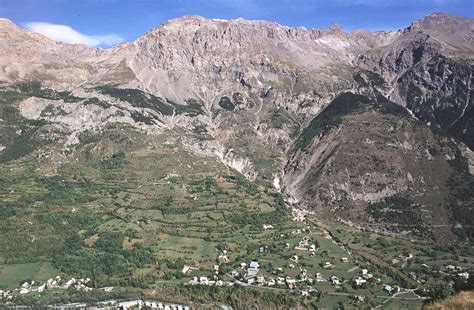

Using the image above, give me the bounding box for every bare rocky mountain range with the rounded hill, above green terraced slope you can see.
[0,13,474,241]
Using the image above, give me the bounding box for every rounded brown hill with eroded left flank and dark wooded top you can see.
[283,93,474,241]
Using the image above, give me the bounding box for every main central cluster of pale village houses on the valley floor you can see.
[182,224,399,301]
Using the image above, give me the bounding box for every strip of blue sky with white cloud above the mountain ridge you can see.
[0,0,474,48]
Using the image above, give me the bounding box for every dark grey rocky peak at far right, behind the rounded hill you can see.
[357,13,474,149]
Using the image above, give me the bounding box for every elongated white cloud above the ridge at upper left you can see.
[25,22,124,46]
